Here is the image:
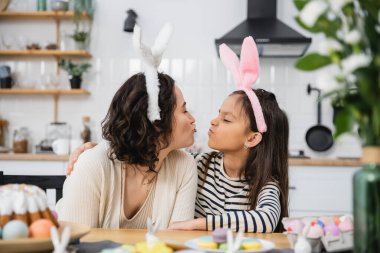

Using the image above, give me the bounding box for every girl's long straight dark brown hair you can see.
[236,89,289,232]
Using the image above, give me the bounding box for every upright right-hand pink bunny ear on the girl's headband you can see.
[240,36,260,88]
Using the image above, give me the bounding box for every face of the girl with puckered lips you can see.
[208,95,252,152]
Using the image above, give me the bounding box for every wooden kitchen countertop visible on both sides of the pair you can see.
[0,153,361,167]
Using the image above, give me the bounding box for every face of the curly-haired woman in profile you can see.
[171,86,195,149]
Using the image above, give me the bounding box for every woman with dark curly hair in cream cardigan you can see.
[57,73,197,228]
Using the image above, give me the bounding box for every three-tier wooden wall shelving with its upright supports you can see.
[0,11,91,122]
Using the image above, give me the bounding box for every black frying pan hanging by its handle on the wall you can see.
[306,84,334,152]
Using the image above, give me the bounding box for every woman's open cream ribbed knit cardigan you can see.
[57,141,197,229]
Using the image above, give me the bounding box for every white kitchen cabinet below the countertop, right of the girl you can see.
[289,165,359,217]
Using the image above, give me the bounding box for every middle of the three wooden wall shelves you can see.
[0,50,91,58]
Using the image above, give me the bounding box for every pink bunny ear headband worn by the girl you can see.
[219,36,267,133]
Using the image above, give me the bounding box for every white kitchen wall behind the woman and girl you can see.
[0,0,360,157]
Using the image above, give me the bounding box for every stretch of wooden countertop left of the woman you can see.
[0,153,69,161]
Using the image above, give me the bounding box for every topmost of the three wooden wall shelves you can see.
[0,11,89,19]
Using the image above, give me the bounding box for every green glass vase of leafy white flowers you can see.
[294,0,380,253]
